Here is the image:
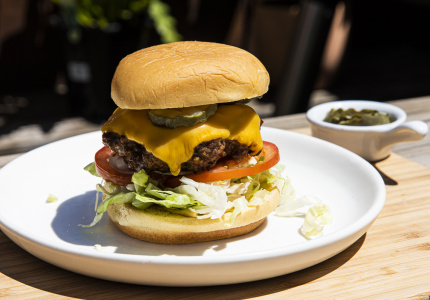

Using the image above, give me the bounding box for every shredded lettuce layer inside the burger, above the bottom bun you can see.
[82,163,279,227]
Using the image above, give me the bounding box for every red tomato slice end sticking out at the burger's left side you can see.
[94,147,132,186]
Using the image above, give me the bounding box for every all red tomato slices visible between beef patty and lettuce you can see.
[95,142,280,187]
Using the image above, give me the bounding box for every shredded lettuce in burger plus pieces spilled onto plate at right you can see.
[80,159,332,239]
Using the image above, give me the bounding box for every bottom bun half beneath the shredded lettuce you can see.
[108,189,280,244]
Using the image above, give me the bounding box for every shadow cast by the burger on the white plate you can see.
[52,191,267,256]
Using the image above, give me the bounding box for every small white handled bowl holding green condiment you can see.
[306,100,428,162]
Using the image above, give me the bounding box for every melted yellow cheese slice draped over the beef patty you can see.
[102,104,263,175]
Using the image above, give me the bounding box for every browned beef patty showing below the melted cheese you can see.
[103,132,251,174]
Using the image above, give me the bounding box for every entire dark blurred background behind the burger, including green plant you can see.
[0,0,430,135]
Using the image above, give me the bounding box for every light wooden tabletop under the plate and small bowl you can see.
[0,97,430,299]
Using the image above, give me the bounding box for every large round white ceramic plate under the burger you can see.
[0,127,385,286]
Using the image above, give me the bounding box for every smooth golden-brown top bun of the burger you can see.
[111,42,269,109]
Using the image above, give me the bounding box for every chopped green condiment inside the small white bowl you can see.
[324,108,395,126]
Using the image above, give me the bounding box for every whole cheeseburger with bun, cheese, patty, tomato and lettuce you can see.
[85,41,282,244]
